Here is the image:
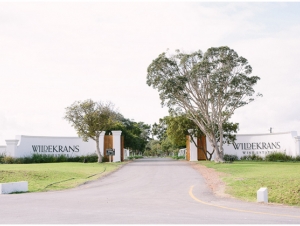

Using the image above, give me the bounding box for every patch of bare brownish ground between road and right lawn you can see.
[189,162,232,198]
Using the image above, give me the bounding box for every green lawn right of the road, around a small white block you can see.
[199,161,300,206]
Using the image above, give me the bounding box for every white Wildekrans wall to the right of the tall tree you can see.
[206,131,300,158]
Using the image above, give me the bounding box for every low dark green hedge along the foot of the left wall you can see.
[0,154,98,164]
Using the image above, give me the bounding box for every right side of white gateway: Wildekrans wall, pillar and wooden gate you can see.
[186,131,300,161]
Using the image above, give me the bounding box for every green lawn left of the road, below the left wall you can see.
[0,162,125,192]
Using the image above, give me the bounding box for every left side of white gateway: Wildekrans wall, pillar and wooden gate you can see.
[0,130,129,162]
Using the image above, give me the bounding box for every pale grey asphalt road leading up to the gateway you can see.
[0,158,300,224]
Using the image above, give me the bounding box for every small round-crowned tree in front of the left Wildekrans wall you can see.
[64,99,118,162]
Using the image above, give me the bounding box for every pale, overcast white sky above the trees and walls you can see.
[0,1,300,145]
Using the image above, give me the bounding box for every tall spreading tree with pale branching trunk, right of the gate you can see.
[147,46,260,162]
